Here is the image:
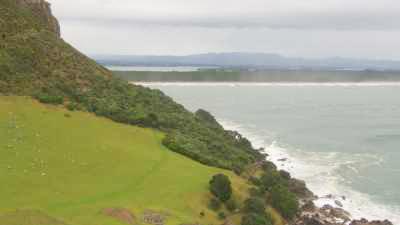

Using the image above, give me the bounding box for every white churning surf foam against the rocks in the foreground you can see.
[219,120,400,225]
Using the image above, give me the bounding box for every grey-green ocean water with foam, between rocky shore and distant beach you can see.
[145,83,400,225]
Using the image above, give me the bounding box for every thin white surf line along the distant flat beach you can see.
[135,82,400,87]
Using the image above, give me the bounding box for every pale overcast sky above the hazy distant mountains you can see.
[48,0,400,59]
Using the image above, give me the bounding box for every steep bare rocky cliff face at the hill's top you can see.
[17,0,61,37]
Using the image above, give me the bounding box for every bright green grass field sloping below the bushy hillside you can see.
[0,97,248,225]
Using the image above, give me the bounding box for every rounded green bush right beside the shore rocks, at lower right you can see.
[271,185,299,219]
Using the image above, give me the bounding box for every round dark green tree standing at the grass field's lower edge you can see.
[210,174,232,202]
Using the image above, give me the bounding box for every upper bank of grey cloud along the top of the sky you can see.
[51,0,400,30]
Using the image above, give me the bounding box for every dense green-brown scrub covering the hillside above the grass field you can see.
[0,0,261,172]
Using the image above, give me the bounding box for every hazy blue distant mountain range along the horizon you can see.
[92,52,400,71]
